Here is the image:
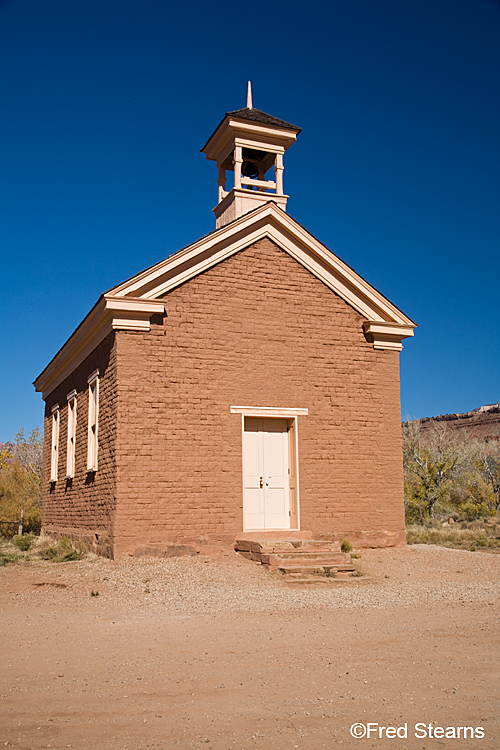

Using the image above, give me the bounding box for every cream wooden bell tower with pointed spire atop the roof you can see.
[201,82,301,229]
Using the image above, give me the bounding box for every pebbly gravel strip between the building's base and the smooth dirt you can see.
[0,545,500,616]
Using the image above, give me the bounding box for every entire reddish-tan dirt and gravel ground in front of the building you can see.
[0,545,500,750]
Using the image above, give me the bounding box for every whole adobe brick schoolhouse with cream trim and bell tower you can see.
[35,95,415,558]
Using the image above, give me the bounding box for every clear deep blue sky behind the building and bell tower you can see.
[0,0,500,441]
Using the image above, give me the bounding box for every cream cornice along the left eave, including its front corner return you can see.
[34,294,165,399]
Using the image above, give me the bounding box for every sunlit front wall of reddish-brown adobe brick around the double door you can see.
[110,240,405,556]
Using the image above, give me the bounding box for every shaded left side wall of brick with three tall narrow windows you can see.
[42,334,116,556]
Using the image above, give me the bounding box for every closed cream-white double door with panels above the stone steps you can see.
[243,417,290,531]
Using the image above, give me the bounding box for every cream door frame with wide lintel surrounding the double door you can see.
[231,406,309,531]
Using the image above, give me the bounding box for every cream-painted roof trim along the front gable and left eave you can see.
[34,202,416,398]
